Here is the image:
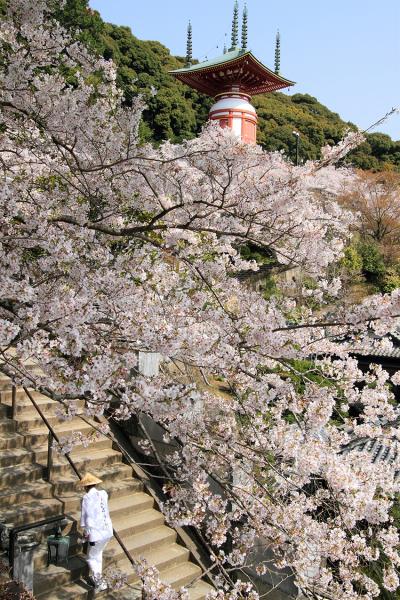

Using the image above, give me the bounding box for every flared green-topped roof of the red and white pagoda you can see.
[170,49,295,96]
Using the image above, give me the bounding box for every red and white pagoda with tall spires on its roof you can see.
[171,1,294,144]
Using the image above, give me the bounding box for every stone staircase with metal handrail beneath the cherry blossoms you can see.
[0,377,213,600]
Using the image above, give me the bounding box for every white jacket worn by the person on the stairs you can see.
[81,488,113,542]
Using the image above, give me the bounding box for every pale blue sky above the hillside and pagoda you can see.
[90,0,400,139]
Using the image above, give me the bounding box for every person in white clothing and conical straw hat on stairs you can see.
[78,473,113,591]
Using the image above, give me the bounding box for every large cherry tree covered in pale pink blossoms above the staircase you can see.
[0,0,400,600]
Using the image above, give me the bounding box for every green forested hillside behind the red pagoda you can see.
[7,0,400,171]
